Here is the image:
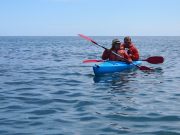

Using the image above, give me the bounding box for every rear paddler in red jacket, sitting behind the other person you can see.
[122,36,139,61]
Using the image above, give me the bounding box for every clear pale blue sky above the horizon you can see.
[0,0,180,36]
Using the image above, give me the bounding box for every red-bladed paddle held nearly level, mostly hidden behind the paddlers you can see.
[83,56,164,64]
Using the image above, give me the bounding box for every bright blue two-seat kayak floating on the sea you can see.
[93,61,142,75]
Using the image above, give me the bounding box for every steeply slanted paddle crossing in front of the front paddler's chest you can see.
[79,34,152,70]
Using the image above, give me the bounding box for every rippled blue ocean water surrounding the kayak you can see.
[0,37,180,135]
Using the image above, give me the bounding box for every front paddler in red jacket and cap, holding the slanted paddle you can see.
[102,39,132,63]
